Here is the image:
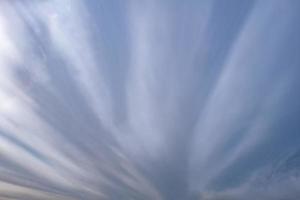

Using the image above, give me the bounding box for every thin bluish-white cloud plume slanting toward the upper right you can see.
[191,2,296,193]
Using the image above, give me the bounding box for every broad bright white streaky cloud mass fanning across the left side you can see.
[0,1,160,199]
